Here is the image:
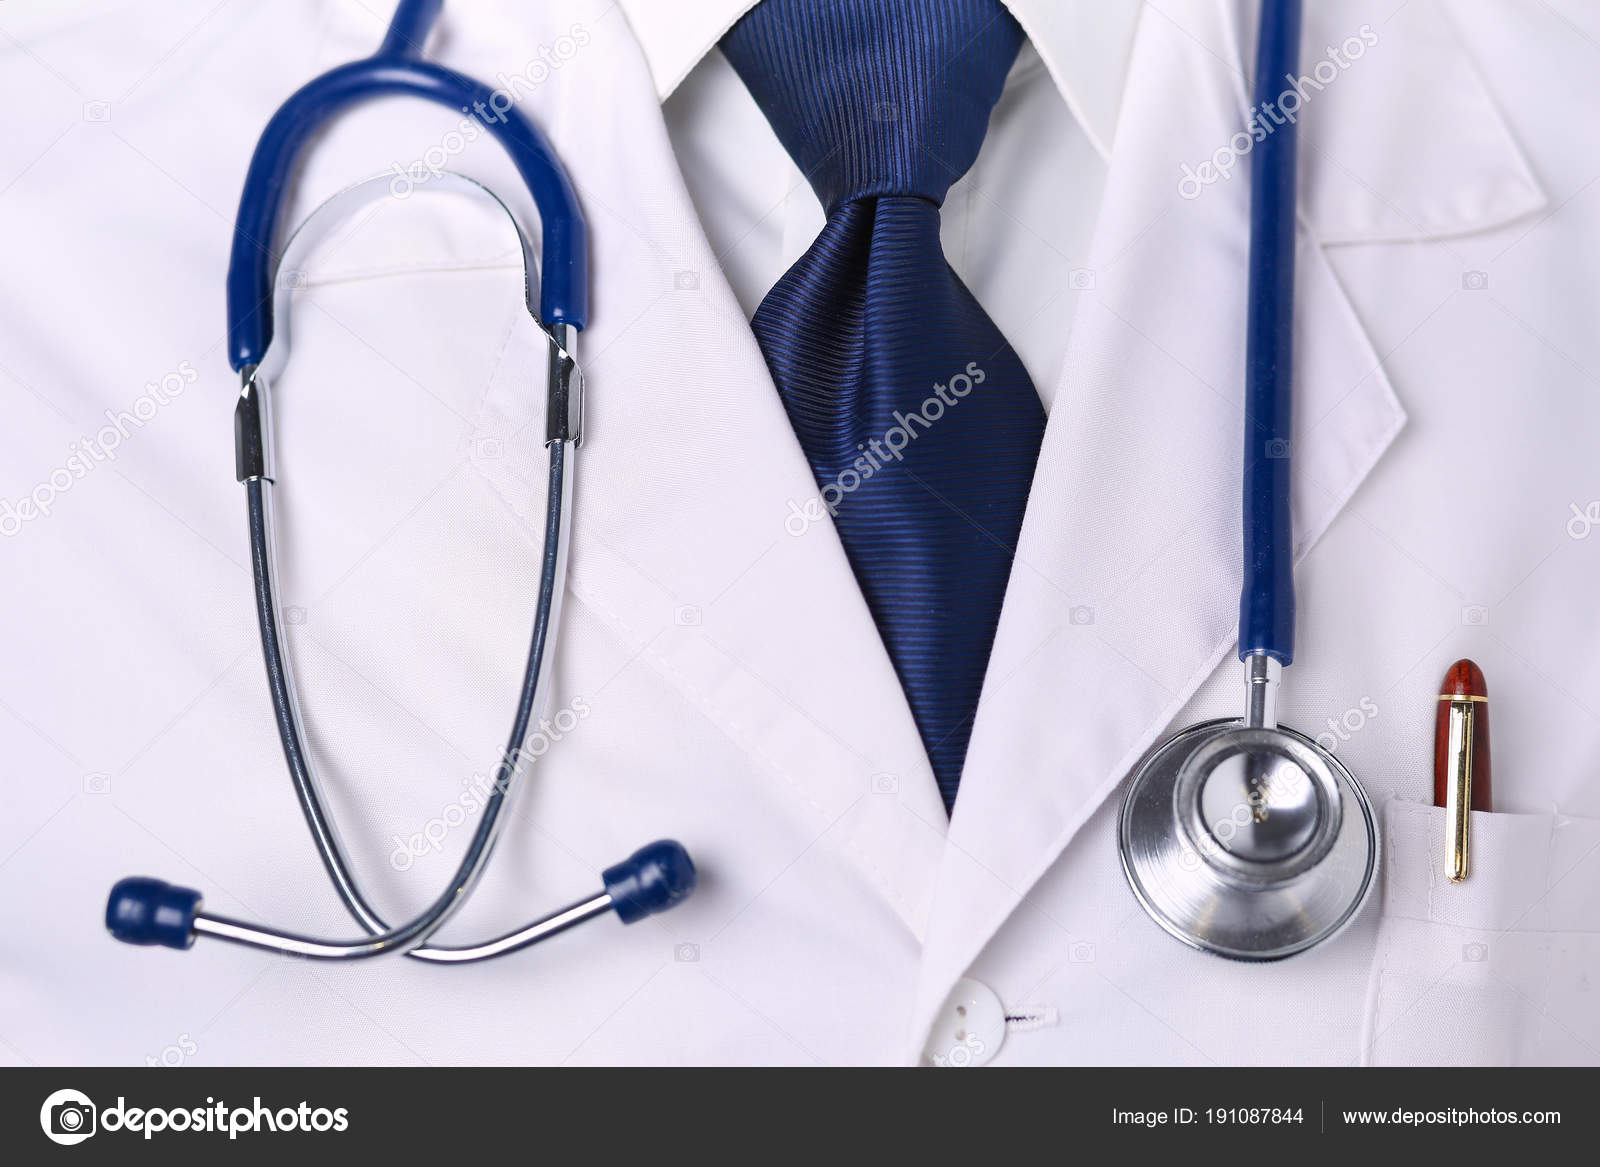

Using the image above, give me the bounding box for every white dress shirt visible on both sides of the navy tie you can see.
[636,0,1138,407]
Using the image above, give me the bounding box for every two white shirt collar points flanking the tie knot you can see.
[618,0,1144,157]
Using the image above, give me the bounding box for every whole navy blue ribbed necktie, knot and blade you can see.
[722,0,1045,808]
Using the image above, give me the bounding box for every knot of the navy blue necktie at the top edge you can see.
[722,0,1022,215]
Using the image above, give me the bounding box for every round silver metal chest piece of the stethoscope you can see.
[1118,719,1378,960]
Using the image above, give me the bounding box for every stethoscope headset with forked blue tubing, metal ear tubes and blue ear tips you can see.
[106,0,696,964]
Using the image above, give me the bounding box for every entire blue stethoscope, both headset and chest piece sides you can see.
[106,0,1378,962]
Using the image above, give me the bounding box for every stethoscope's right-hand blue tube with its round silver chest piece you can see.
[1117,0,1378,960]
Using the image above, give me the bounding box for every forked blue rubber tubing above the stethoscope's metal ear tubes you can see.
[227,0,589,371]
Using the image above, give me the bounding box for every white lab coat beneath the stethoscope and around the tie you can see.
[0,0,1600,1065]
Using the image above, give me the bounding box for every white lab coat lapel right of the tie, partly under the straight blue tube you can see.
[914,5,1403,1047]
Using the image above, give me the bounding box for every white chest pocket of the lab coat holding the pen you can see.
[1362,802,1600,1065]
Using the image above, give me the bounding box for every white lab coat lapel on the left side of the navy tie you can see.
[473,6,947,935]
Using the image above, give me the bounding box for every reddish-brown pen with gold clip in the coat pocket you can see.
[1434,660,1494,884]
